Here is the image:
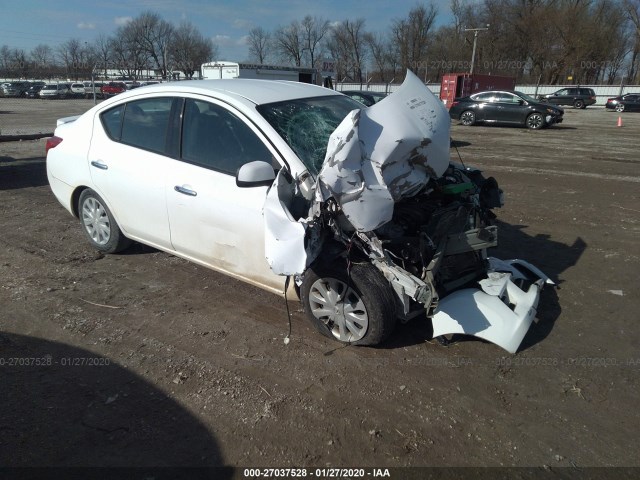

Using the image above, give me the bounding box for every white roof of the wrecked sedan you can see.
[131,78,340,105]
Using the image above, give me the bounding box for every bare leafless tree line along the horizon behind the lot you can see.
[0,0,640,84]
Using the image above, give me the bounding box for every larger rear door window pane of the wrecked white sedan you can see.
[120,97,174,154]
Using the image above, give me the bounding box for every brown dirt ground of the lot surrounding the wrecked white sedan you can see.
[0,108,640,478]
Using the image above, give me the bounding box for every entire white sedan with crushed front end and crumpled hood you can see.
[46,73,548,352]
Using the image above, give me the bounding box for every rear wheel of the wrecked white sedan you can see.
[78,189,131,253]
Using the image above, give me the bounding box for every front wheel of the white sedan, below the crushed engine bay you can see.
[300,260,396,346]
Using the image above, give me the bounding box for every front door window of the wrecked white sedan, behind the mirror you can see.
[181,99,273,175]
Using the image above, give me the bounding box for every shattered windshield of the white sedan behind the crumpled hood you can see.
[258,95,363,176]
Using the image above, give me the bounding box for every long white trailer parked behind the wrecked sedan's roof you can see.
[200,61,316,83]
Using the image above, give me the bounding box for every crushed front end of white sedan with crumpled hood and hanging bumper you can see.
[264,72,552,353]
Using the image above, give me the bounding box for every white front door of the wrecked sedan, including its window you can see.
[166,98,285,292]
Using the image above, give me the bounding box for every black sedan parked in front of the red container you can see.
[449,90,564,130]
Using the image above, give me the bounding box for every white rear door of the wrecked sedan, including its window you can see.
[88,97,179,249]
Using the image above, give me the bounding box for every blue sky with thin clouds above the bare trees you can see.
[0,0,458,62]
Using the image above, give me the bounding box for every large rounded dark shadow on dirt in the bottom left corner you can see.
[0,333,228,472]
